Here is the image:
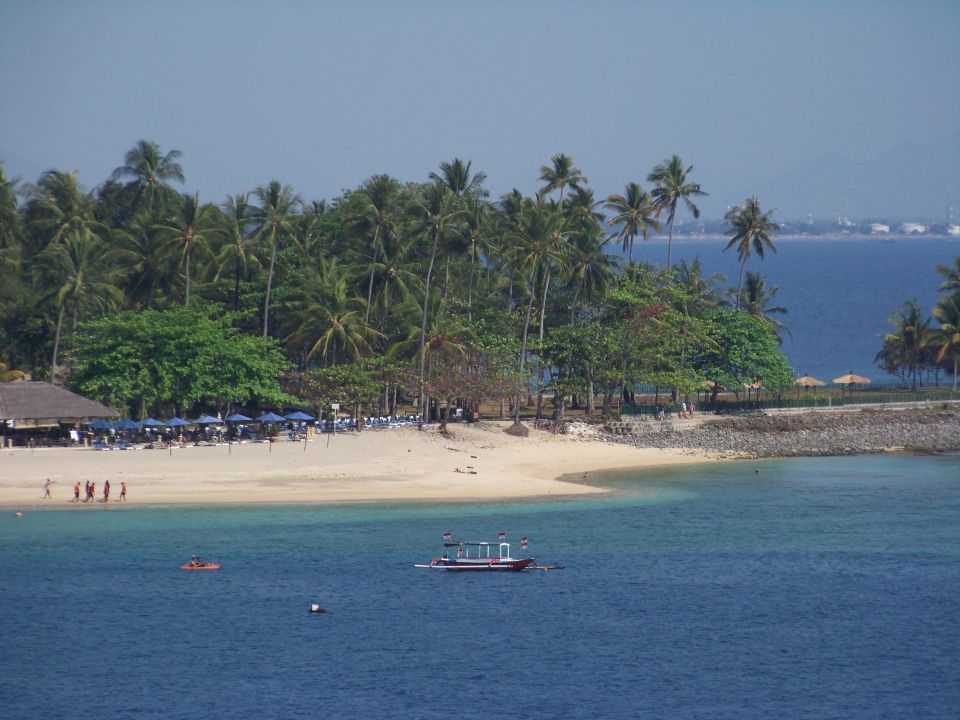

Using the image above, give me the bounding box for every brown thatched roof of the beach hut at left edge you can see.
[0,382,120,427]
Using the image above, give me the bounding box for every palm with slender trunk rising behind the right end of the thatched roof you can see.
[43,229,123,382]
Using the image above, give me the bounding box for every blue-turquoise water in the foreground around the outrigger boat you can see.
[0,456,960,720]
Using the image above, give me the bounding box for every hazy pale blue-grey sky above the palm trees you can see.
[0,0,960,222]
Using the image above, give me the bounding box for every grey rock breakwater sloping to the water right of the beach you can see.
[607,409,960,457]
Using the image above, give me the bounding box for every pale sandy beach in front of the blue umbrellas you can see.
[0,422,716,509]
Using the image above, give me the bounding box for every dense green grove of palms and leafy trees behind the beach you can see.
[0,140,808,421]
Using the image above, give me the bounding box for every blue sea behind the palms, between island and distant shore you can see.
[633,238,960,383]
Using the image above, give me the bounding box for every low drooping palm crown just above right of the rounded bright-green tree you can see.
[286,258,382,364]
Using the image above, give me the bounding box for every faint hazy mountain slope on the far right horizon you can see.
[744,133,960,223]
